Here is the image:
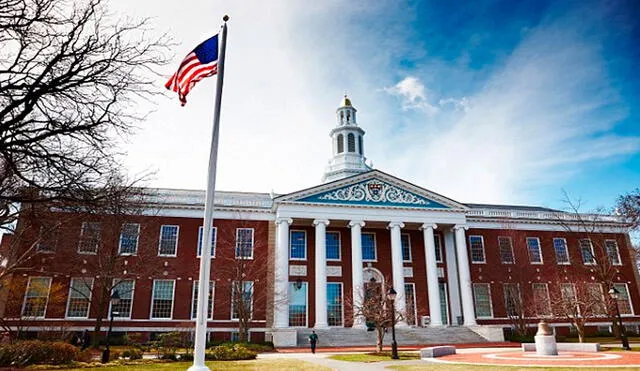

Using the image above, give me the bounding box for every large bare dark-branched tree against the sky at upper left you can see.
[0,0,167,226]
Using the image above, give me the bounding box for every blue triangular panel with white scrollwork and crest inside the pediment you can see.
[299,179,446,208]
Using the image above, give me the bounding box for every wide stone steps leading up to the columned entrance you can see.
[296,326,488,347]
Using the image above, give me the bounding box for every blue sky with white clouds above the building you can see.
[113,0,640,214]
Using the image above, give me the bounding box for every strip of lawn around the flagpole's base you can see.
[40,359,330,371]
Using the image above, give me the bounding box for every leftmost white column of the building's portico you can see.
[273,218,293,328]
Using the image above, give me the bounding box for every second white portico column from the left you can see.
[313,220,329,329]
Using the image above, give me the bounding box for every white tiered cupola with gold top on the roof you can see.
[322,95,371,183]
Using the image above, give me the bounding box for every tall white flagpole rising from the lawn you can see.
[189,15,229,371]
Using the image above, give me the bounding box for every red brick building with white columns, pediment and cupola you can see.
[3,97,640,345]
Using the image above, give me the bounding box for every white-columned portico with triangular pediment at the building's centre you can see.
[274,170,475,336]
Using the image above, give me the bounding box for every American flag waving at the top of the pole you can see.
[164,35,218,106]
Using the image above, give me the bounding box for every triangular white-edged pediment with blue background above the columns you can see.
[275,170,467,209]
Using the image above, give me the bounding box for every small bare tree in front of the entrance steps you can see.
[345,277,405,353]
